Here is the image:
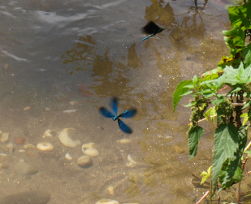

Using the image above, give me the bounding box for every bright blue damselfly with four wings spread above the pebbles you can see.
[99,97,137,134]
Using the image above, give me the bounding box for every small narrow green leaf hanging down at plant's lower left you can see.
[188,126,204,157]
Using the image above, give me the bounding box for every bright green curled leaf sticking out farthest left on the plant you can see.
[172,80,192,110]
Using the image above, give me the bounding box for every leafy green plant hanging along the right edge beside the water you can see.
[173,0,251,202]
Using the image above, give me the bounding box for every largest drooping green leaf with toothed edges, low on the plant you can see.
[212,124,239,184]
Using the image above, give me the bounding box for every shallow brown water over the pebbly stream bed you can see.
[0,0,232,204]
